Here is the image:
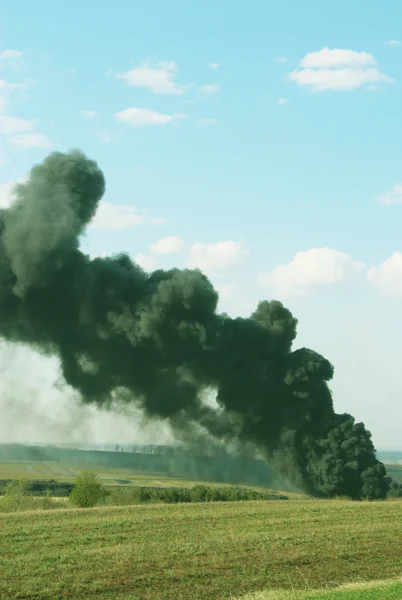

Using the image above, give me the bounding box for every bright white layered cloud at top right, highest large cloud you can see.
[289,48,394,92]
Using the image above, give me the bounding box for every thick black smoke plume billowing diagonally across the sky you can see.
[0,151,396,498]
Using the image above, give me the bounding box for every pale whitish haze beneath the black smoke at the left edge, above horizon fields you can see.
[0,342,173,445]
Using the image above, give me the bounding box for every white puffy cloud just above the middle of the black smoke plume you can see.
[187,240,249,271]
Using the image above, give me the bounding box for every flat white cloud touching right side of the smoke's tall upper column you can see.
[90,202,161,231]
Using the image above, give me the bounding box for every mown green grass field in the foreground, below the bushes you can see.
[0,500,402,600]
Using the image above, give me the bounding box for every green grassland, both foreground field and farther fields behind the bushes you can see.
[0,446,402,600]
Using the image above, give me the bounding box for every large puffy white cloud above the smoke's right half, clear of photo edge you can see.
[259,248,365,296]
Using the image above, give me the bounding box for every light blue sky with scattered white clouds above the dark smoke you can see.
[0,0,402,448]
